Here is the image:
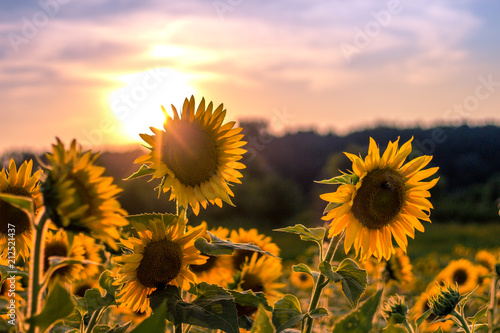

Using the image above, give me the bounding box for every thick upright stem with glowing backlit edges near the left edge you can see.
[28,212,48,333]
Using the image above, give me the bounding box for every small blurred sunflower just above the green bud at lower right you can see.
[436,259,479,295]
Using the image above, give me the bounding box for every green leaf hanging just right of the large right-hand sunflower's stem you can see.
[336,258,368,307]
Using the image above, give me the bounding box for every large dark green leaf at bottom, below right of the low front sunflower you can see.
[150,283,239,333]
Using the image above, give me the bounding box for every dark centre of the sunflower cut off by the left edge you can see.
[0,186,31,235]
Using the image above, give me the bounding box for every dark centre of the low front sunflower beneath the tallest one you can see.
[137,239,182,288]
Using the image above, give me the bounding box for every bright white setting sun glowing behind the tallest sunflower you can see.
[109,68,196,141]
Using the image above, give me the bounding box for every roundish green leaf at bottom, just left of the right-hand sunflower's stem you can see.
[272,294,306,332]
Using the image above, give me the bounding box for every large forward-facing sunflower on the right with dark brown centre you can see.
[320,138,439,260]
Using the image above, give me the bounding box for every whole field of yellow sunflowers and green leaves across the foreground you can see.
[0,97,500,333]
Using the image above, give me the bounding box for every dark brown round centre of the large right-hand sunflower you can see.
[352,169,406,229]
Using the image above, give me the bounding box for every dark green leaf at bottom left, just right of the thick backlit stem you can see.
[27,283,75,332]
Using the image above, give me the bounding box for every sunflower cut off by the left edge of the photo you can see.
[0,159,42,261]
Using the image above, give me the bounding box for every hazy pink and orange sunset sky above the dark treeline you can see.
[0,0,500,153]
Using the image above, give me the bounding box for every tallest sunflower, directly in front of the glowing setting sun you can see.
[134,96,246,215]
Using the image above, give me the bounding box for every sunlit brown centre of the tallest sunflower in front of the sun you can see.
[161,120,218,187]
